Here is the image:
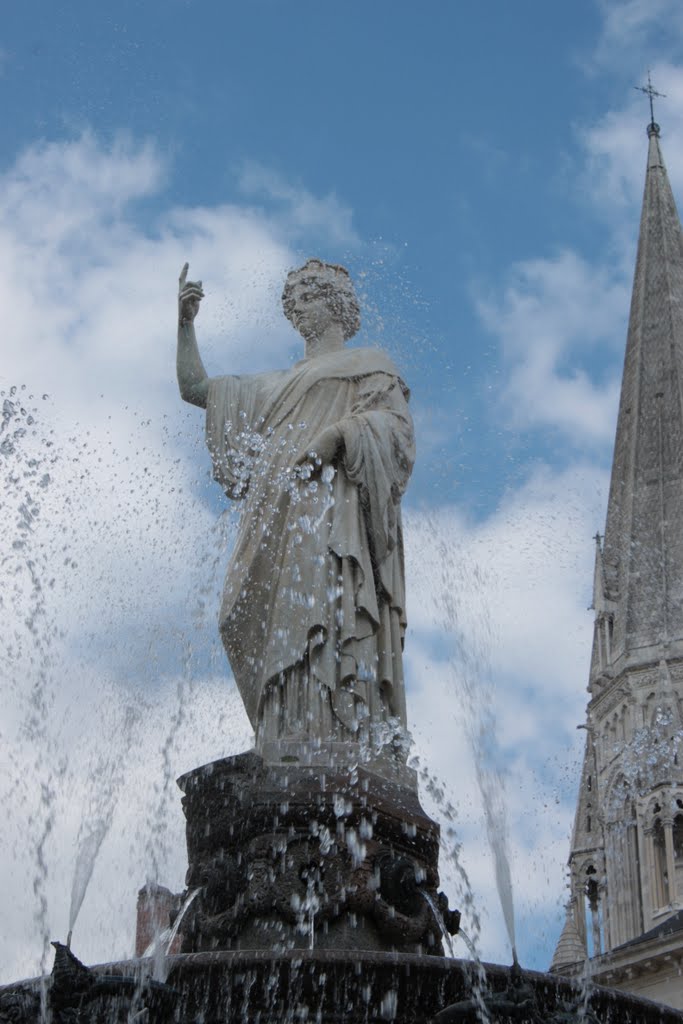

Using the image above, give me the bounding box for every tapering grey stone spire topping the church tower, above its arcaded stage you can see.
[592,119,683,677]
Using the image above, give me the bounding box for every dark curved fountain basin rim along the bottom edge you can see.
[0,950,683,1024]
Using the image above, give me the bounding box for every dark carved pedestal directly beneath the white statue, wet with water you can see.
[178,752,457,954]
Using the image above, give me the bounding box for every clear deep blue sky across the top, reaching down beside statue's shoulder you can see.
[3,0,618,507]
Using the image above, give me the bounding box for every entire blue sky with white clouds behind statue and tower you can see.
[0,0,683,978]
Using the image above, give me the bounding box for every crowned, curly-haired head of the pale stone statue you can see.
[283,259,360,341]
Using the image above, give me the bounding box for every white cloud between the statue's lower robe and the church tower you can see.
[407,465,607,757]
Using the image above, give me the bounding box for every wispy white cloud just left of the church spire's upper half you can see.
[477,50,683,453]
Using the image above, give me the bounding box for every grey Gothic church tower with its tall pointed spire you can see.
[551,120,683,1009]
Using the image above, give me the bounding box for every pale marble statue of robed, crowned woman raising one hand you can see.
[177,259,415,760]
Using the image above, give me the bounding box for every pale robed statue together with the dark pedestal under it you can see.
[171,260,459,952]
